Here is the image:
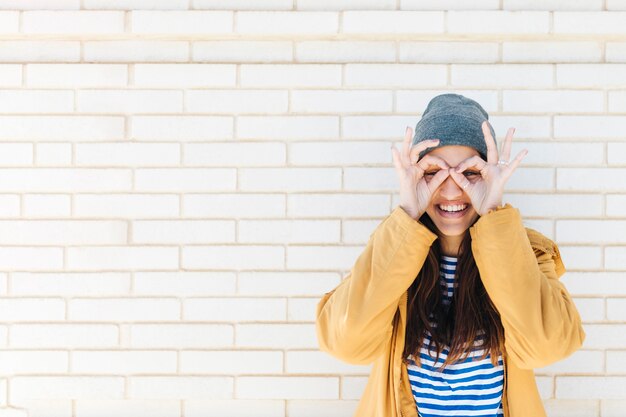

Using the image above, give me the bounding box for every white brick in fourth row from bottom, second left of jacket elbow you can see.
[130,323,234,349]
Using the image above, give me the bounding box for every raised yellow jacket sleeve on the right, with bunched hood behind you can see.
[470,204,585,369]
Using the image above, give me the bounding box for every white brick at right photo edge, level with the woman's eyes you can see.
[556,168,626,192]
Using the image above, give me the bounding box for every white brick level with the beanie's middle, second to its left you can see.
[237,116,339,140]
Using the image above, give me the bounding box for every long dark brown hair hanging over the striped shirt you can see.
[403,213,506,370]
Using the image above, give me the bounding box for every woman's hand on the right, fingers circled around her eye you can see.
[450,121,528,216]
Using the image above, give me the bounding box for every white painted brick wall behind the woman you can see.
[0,0,626,417]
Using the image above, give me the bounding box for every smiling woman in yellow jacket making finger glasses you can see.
[316,94,585,417]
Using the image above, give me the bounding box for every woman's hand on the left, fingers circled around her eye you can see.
[391,127,450,220]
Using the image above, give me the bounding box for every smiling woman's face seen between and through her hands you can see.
[424,145,482,237]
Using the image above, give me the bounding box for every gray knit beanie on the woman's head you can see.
[412,94,497,160]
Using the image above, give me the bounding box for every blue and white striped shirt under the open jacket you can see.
[407,256,504,417]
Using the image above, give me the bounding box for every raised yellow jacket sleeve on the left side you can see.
[316,206,437,364]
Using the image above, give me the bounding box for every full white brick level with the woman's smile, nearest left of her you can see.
[287,193,389,218]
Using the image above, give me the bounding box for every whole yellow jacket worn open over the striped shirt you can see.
[316,204,585,417]
